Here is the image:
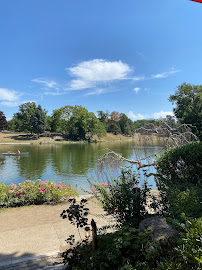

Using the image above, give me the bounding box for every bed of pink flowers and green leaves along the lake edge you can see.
[0,179,78,207]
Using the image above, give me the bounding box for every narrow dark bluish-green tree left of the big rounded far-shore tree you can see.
[30,105,46,134]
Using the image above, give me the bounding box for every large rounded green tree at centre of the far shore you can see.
[67,106,106,140]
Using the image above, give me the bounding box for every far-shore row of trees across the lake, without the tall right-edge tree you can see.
[0,102,175,140]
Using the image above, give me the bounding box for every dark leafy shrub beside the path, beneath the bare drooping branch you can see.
[89,168,150,226]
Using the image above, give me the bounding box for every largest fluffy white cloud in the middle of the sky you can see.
[66,59,132,90]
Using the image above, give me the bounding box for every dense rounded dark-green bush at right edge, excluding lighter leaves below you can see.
[156,142,202,190]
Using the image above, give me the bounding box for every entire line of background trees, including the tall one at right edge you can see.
[0,83,202,140]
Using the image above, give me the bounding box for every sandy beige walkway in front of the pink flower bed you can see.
[0,196,110,270]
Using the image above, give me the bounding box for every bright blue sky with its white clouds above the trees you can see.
[0,0,202,120]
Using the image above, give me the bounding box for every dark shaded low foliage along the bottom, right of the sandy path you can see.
[62,226,177,270]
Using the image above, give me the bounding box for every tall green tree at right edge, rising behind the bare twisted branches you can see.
[169,83,202,140]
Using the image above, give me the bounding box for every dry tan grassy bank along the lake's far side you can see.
[0,132,164,145]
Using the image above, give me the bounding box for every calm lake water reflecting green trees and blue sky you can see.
[0,141,159,194]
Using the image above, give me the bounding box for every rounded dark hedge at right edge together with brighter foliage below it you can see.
[156,142,202,218]
